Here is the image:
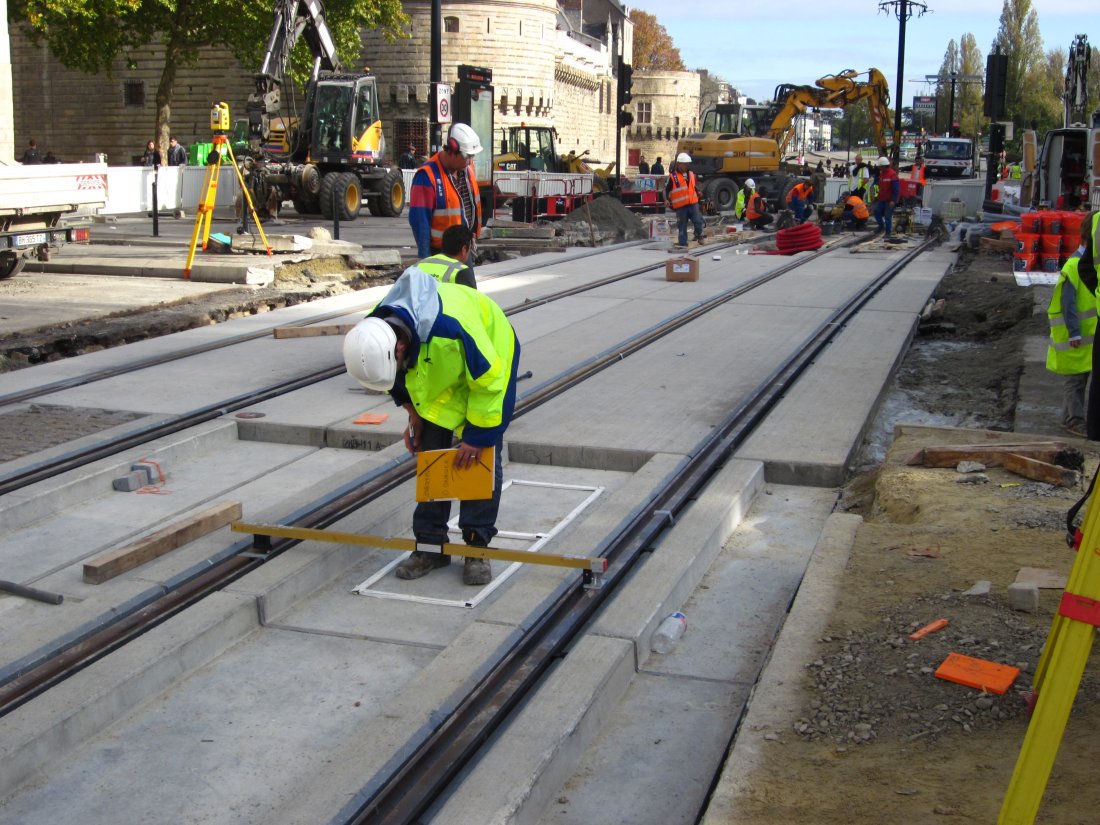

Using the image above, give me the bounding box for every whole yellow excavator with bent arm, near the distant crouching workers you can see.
[677,68,890,212]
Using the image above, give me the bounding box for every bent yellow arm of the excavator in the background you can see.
[768,68,890,157]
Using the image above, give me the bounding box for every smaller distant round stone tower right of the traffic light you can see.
[625,72,701,174]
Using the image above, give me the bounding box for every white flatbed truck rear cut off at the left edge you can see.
[0,163,107,279]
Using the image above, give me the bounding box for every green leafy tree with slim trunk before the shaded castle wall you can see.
[9,0,408,154]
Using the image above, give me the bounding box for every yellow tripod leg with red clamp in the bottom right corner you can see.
[997,481,1100,825]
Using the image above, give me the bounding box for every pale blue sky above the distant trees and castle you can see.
[627,0,1086,106]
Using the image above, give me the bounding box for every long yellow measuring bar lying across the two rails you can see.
[230,521,607,576]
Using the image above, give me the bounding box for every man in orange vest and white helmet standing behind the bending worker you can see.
[409,123,482,263]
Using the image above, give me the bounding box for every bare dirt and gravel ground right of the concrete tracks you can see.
[705,255,1100,825]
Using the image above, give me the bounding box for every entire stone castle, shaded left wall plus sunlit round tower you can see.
[11,0,633,165]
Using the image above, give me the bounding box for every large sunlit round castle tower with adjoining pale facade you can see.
[363,0,633,169]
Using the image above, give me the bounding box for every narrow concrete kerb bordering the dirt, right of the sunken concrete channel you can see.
[702,513,862,825]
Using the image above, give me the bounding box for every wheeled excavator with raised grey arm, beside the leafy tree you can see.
[239,0,405,221]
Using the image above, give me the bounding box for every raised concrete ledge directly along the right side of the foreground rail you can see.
[432,461,763,823]
